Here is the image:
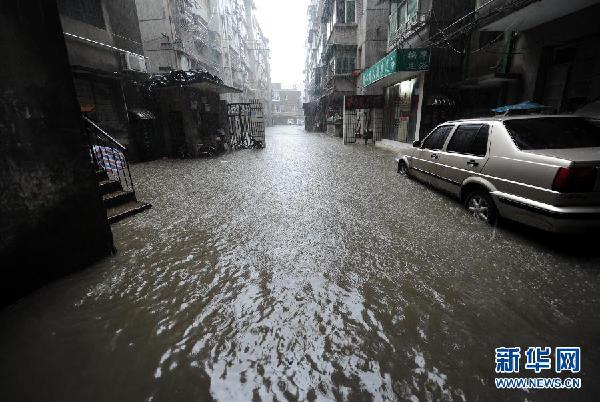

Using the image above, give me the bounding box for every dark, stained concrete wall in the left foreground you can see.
[0,0,112,304]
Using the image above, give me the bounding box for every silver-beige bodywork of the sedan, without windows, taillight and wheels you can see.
[397,116,600,232]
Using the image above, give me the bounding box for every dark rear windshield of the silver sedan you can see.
[504,117,600,150]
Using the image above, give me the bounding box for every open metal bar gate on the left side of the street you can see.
[227,99,266,149]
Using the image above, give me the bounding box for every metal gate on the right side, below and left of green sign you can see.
[343,95,383,144]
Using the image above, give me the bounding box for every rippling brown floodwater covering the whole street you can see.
[0,127,600,401]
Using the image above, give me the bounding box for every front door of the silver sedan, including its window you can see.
[411,124,454,187]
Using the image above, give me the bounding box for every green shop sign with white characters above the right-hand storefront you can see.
[362,49,431,87]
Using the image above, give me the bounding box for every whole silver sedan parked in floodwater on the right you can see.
[397,115,600,232]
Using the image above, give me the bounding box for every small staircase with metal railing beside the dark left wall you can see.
[83,116,152,224]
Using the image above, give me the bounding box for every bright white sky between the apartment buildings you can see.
[254,0,309,89]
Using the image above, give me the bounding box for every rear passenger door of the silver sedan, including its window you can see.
[438,123,490,194]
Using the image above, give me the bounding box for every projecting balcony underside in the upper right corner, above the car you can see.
[478,0,598,31]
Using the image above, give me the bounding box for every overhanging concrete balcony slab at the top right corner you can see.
[481,0,598,31]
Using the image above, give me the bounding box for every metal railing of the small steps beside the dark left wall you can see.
[83,115,135,196]
